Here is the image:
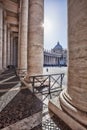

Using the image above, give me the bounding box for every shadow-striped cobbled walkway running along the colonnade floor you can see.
[0,70,70,130]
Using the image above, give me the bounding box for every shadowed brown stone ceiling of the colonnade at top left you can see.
[0,0,20,33]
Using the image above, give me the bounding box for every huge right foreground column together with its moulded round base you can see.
[50,0,87,130]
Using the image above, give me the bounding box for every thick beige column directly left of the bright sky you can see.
[27,0,44,78]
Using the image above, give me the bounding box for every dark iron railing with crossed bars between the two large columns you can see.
[30,73,64,94]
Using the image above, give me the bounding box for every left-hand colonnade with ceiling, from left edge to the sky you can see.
[0,0,44,80]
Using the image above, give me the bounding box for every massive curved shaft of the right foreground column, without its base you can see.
[68,0,87,112]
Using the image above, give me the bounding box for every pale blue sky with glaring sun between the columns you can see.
[44,0,67,50]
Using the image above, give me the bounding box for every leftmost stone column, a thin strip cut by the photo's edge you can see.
[0,5,3,72]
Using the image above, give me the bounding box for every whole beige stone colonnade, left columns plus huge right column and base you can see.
[0,0,87,130]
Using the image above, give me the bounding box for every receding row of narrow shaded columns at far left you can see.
[0,4,17,72]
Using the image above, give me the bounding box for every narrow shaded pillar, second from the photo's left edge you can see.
[3,22,7,69]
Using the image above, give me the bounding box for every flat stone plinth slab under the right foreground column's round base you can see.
[48,97,87,130]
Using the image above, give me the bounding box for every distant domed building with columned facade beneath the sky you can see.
[44,42,67,66]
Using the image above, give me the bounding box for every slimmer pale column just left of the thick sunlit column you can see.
[18,0,29,75]
